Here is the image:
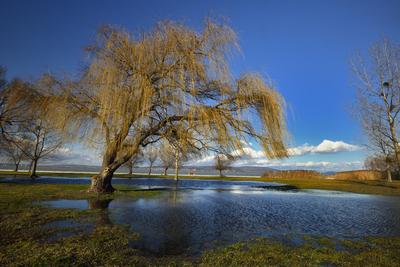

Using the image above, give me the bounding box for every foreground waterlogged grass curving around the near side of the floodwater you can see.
[0,183,400,266]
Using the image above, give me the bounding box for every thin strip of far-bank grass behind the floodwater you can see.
[0,171,400,196]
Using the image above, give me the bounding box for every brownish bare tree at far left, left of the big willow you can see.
[0,74,62,178]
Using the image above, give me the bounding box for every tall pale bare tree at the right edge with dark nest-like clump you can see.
[352,39,400,176]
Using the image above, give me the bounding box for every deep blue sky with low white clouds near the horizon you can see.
[0,0,400,170]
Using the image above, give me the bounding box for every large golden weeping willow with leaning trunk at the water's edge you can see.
[52,21,287,193]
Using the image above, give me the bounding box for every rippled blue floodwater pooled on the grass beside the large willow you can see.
[29,178,400,255]
